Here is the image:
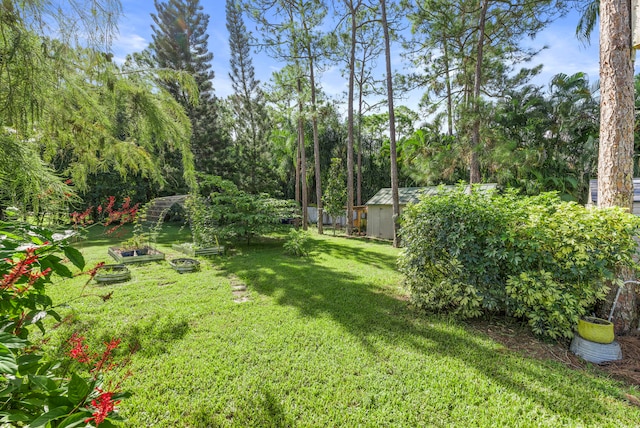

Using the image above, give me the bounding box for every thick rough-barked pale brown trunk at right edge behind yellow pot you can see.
[598,0,638,333]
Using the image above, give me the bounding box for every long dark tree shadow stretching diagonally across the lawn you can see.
[222,238,636,423]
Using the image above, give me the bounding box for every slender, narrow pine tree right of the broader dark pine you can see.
[226,0,276,193]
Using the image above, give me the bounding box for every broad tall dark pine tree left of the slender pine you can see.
[150,0,229,181]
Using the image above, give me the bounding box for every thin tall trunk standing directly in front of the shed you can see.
[380,0,400,247]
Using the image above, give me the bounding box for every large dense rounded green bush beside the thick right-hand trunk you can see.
[400,188,640,338]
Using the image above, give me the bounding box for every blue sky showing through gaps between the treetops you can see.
[113,0,599,109]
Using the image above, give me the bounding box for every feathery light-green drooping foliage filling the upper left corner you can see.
[0,12,193,212]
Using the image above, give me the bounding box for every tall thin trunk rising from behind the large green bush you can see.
[469,0,489,184]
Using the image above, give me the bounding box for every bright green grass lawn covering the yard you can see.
[45,227,640,427]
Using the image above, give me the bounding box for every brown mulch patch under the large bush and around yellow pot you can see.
[469,320,640,386]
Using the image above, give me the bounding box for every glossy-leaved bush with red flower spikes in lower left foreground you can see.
[0,216,128,427]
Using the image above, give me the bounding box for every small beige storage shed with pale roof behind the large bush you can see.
[367,183,496,239]
